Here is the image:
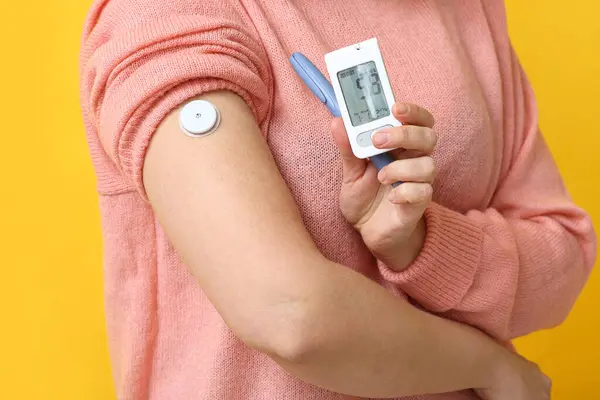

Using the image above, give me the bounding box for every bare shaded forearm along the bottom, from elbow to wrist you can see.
[278,258,508,398]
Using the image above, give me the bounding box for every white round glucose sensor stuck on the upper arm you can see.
[179,100,221,137]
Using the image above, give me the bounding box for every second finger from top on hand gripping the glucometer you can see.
[373,125,437,154]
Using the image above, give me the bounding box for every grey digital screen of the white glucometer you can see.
[337,61,390,126]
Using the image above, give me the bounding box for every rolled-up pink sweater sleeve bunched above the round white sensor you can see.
[80,0,272,195]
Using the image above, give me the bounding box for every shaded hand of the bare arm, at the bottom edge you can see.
[475,353,552,400]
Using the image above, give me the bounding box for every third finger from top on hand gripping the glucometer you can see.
[377,157,436,185]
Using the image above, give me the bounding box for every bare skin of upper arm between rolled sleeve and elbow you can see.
[144,92,320,341]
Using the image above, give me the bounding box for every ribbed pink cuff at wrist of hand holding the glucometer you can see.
[378,204,483,312]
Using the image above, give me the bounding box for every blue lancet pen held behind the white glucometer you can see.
[290,53,402,187]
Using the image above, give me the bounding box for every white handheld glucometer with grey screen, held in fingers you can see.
[325,38,402,158]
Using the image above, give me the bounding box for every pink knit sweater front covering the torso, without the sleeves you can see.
[97,0,509,400]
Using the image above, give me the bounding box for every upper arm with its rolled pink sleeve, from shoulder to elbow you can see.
[80,0,322,354]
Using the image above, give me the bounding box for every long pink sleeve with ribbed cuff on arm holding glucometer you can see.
[379,49,596,340]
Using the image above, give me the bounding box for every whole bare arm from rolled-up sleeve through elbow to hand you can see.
[144,92,548,400]
